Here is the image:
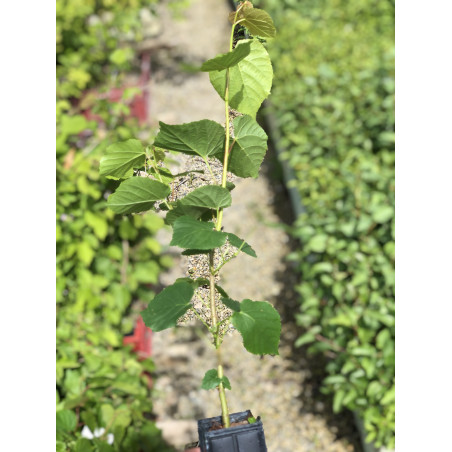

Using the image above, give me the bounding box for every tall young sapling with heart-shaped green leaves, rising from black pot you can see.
[100,1,281,428]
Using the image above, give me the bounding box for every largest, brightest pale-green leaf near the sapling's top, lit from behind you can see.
[209,40,273,118]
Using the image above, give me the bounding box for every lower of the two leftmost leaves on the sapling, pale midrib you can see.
[107,177,171,214]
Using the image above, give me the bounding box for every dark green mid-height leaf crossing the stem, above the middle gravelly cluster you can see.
[170,216,227,250]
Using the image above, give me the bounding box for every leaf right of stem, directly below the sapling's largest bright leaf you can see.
[228,115,268,177]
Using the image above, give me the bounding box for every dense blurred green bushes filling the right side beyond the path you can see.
[261,0,394,448]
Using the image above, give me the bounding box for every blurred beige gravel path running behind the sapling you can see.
[146,0,361,452]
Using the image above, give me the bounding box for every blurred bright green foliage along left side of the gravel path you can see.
[56,0,175,451]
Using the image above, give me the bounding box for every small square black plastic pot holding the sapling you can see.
[198,410,267,452]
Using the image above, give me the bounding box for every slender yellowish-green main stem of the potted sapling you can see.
[209,10,239,428]
